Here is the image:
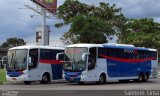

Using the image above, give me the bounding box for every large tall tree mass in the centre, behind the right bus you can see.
[56,0,126,43]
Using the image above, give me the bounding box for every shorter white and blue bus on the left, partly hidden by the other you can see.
[6,46,64,84]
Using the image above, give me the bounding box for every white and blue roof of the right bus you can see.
[67,43,157,51]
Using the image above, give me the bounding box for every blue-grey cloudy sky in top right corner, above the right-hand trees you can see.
[110,0,160,18]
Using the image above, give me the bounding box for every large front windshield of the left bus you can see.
[6,49,27,71]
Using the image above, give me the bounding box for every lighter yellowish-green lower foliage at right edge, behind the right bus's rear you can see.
[120,31,160,49]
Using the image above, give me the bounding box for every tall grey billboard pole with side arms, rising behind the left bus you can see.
[25,0,57,46]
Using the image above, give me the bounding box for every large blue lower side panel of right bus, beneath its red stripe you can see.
[106,60,151,77]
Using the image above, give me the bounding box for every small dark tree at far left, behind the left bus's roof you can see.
[0,38,26,49]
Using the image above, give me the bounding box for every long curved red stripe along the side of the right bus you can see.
[98,54,155,63]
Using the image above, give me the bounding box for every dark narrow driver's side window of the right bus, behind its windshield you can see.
[88,47,97,70]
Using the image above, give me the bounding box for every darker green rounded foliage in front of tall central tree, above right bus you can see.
[64,16,114,43]
